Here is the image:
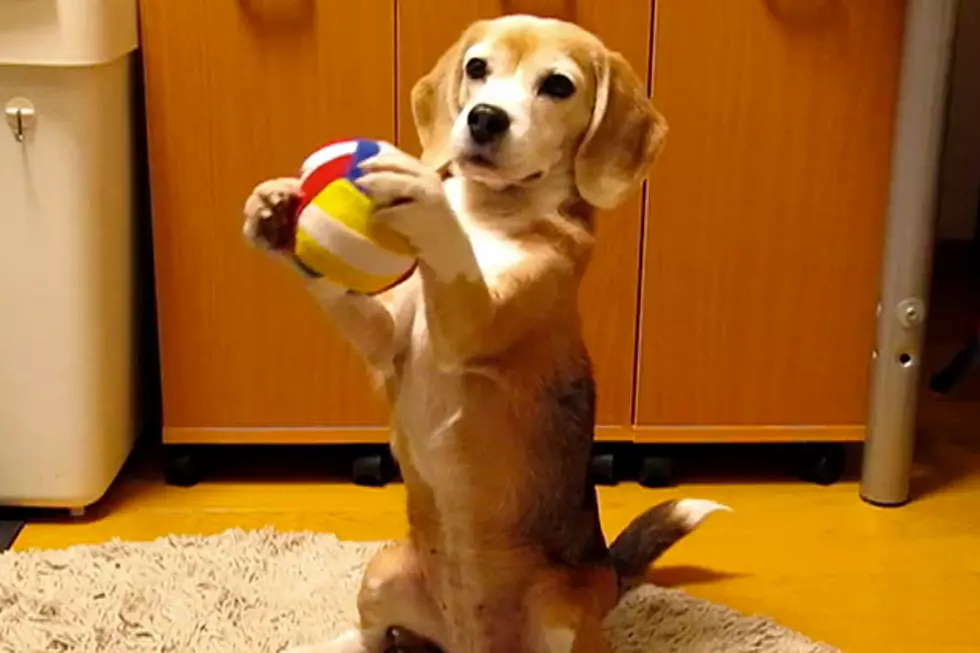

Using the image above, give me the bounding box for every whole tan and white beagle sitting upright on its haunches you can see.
[245,16,721,653]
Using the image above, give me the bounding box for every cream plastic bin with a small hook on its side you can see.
[0,0,138,511]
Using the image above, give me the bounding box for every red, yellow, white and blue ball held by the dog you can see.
[293,139,416,294]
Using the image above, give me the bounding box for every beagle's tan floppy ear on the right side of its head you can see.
[575,52,667,209]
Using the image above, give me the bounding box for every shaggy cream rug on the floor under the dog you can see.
[0,530,836,653]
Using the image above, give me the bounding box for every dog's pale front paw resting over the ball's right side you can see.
[357,147,453,254]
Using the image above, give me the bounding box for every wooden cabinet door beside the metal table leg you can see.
[637,0,904,440]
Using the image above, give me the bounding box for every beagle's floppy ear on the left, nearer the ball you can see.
[412,27,473,169]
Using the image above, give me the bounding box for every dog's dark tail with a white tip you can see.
[609,499,731,590]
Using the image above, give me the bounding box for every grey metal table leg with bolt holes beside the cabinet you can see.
[861,0,957,506]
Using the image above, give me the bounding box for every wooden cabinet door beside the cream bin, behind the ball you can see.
[141,0,395,441]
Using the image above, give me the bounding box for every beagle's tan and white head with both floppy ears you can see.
[412,16,667,208]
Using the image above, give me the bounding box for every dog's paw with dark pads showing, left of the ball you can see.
[242,177,300,252]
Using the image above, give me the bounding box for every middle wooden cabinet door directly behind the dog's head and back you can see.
[398,0,652,438]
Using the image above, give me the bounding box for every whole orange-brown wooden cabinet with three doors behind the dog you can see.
[141,0,903,443]
